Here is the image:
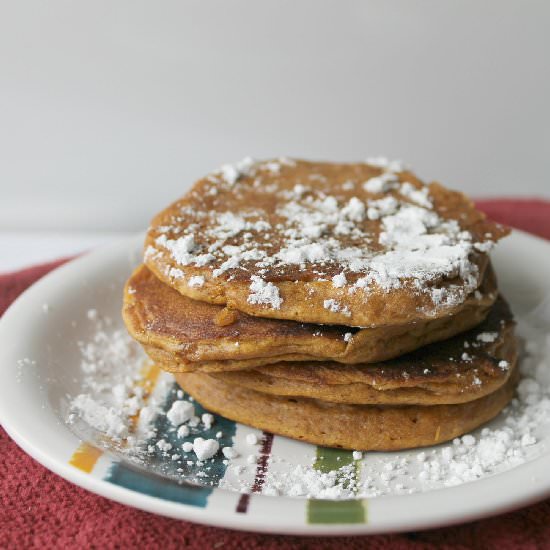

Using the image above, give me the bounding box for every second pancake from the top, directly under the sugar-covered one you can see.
[123,266,497,372]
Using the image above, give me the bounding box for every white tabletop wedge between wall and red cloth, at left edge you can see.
[0,231,131,273]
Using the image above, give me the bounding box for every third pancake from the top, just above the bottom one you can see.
[211,298,517,405]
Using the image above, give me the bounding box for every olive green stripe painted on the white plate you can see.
[307,447,367,524]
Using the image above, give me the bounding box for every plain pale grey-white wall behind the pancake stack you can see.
[0,0,550,235]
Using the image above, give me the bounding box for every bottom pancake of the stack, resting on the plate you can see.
[176,368,519,451]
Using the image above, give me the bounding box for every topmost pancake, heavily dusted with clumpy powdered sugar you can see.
[145,159,508,327]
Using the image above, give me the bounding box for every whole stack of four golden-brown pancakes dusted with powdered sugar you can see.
[123,158,518,450]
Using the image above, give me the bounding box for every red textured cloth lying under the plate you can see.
[0,199,550,550]
